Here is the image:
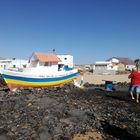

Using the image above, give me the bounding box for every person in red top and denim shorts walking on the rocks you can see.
[128,69,140,103]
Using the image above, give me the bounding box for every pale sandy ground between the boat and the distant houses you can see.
[77,73,130,84]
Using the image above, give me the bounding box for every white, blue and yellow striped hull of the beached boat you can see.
[2,71,78,91]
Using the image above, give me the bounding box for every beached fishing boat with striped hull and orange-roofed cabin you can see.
[1,52,78,91]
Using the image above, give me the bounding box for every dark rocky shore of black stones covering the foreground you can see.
[0,84,140,140]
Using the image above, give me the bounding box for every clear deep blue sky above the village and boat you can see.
[0,0,140,64]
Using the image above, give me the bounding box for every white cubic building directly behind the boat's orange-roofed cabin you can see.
[57,55,74,69]
